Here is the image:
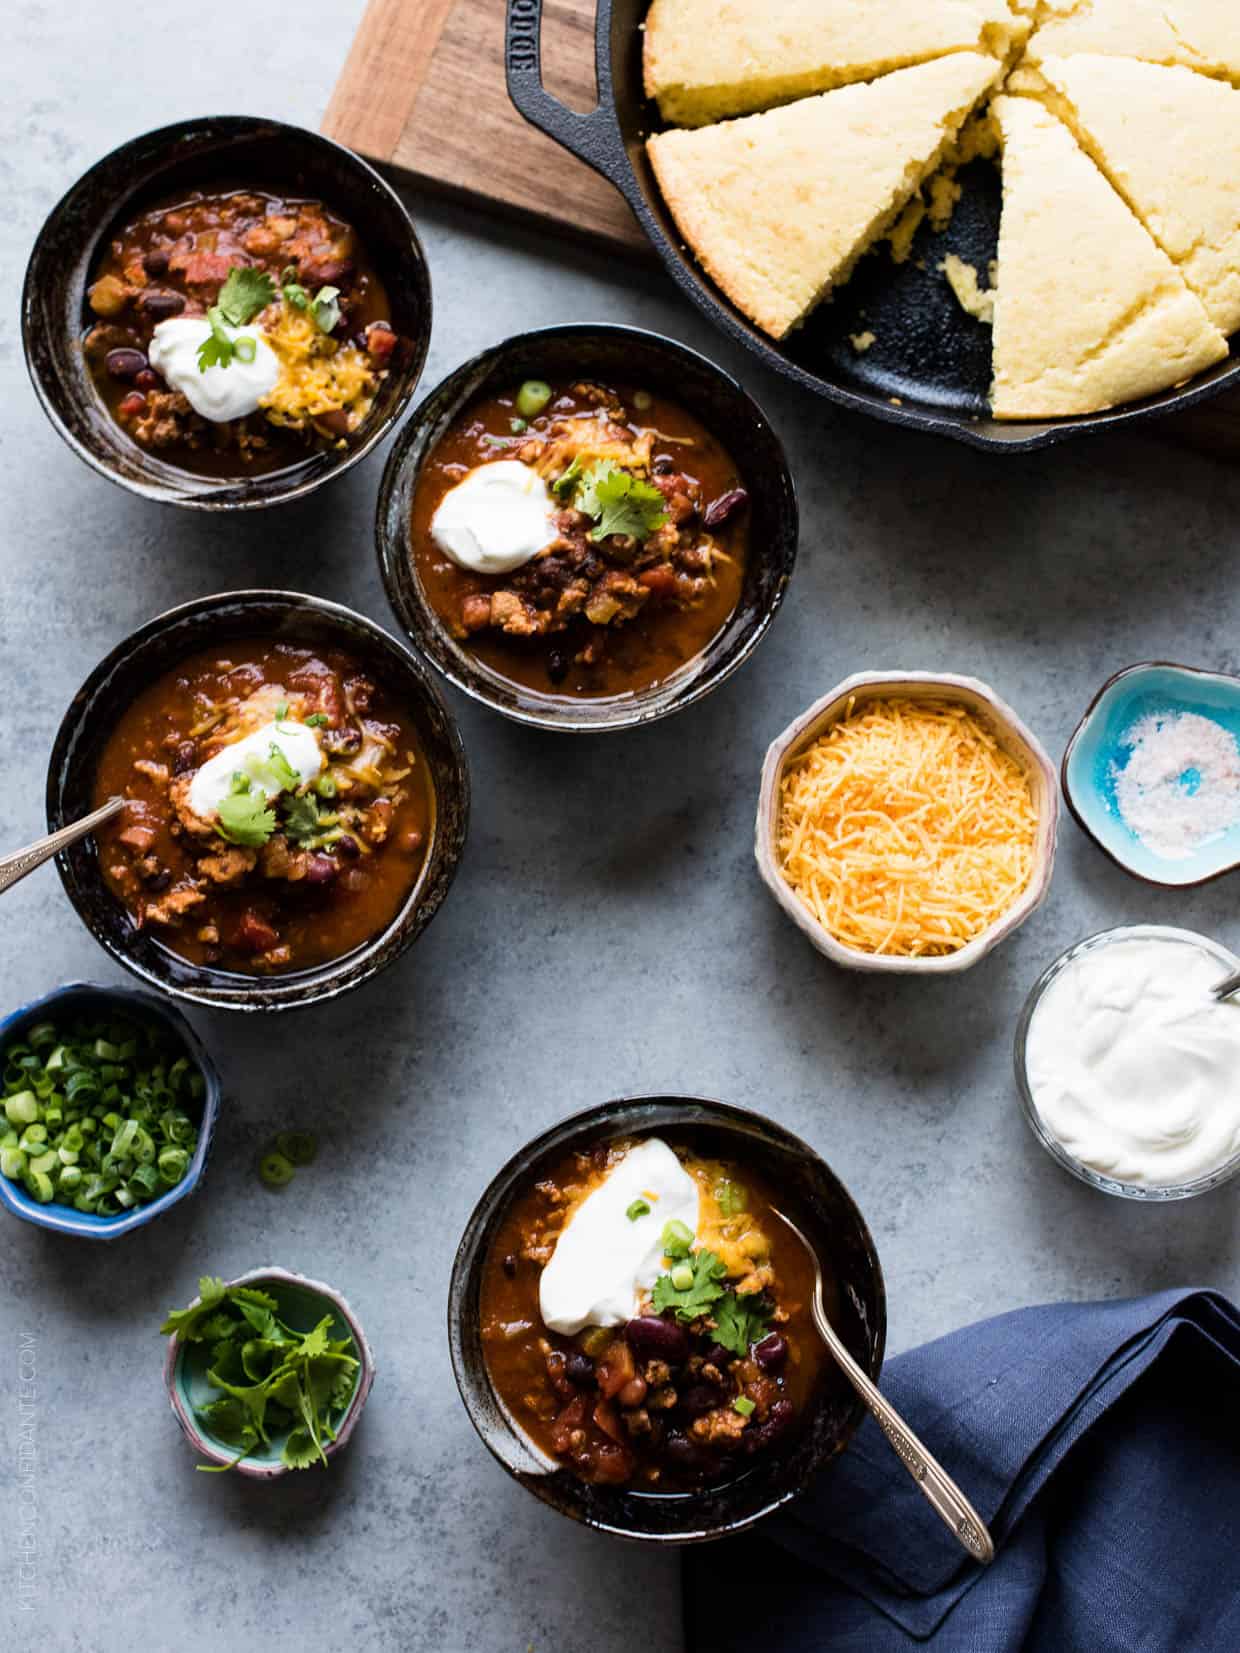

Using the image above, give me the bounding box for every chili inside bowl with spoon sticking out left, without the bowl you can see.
[94,641,435,975]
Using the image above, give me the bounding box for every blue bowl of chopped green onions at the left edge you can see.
[0,982,220,1240]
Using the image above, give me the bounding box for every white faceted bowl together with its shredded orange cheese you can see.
[754,671,1058,974]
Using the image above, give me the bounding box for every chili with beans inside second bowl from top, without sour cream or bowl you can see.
[412,382,749,696]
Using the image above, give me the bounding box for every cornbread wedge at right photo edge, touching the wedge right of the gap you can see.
[1042,55,1240,334]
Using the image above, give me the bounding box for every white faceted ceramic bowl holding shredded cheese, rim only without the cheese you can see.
[754,671,1060,975]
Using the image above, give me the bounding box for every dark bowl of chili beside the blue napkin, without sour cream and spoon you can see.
[448,1096,886,1544]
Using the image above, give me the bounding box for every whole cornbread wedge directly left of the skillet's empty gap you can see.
[646,51,1004,339]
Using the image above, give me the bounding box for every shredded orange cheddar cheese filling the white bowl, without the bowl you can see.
[779,699,1037,957]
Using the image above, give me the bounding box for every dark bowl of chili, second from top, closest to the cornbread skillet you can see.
[375,324,797,732]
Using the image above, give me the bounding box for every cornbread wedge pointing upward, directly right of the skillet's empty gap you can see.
[992,98,1227,418]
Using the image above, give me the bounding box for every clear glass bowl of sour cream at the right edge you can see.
[1015,924,1240,1200]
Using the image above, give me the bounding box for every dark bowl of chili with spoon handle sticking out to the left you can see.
[48,592,470,1010]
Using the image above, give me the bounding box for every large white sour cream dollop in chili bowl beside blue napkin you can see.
[539,1137,698,1337]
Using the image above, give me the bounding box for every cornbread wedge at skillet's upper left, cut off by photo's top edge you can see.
[643,0,1028,126]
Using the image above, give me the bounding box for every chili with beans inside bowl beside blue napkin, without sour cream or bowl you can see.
[481,1141,835,1493]
